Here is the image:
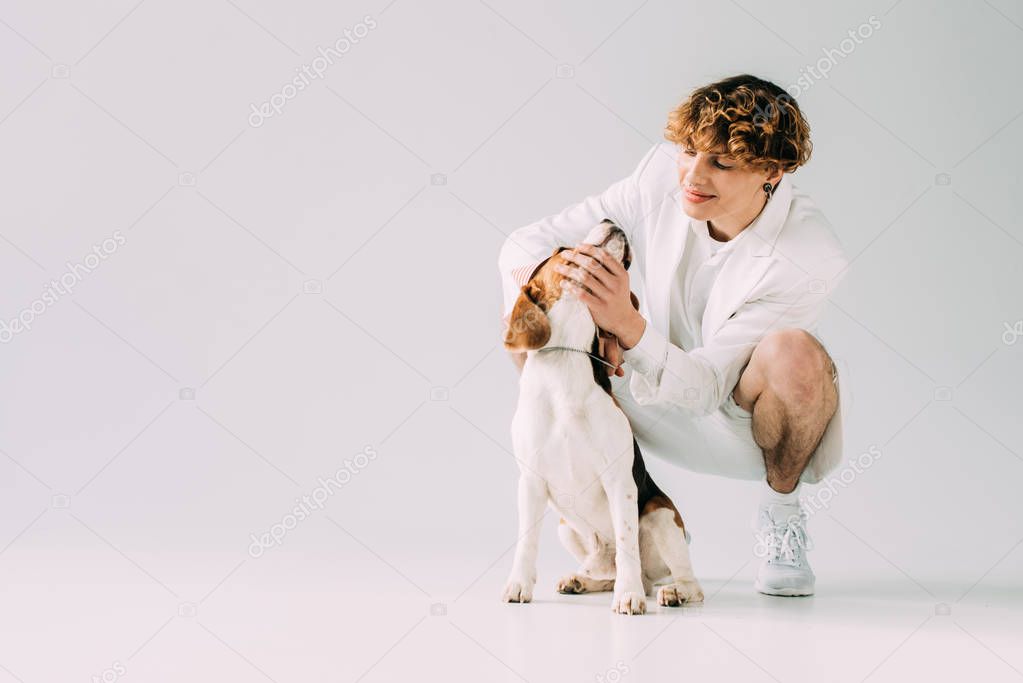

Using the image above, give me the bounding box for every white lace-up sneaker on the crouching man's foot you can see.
[753,502,814,595]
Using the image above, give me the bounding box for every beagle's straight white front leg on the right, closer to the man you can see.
[604,470,647,614]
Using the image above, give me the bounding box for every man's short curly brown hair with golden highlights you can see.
[664,74,813,173]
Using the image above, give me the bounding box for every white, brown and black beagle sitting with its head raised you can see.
[502,220,704,614]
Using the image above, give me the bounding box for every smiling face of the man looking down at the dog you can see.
[678,148,776,223]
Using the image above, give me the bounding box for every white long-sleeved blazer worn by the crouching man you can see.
[498,142,849,483]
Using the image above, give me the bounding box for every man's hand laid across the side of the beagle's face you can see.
[555,243,647,349]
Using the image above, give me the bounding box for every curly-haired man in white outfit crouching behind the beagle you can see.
[498,75,848,595]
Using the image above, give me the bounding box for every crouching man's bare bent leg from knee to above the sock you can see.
[732,328,838,493]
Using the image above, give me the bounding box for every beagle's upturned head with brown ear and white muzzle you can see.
[504,219,632,352]
